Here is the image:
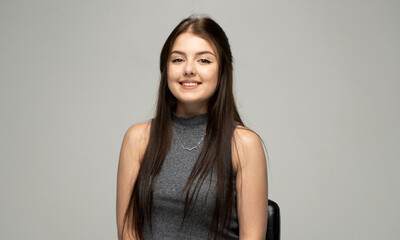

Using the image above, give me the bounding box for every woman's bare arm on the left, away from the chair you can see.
[116,122,150,240]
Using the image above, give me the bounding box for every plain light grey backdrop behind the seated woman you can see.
[0,0,400,240]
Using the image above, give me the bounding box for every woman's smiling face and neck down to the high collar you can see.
[168,32,218,114]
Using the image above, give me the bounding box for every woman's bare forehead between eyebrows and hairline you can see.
[172,32,215,54]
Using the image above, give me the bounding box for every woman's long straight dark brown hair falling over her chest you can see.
[123,16,243,239]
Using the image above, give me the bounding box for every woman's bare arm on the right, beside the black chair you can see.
[232,126,268,240]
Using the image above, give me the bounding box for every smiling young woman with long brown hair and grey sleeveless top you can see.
[117,17,268,240]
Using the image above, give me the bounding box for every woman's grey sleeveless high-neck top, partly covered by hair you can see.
[144,113,239,240]
